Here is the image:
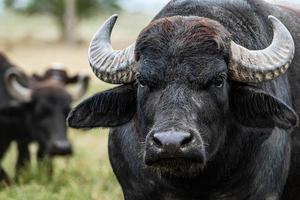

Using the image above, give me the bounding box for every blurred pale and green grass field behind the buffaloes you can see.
[0,10,154,200]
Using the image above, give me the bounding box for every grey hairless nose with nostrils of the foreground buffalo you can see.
[153,131,193,149]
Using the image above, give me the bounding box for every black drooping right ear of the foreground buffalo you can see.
[230,86,298,129]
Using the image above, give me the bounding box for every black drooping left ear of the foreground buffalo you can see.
[67,85,136,128]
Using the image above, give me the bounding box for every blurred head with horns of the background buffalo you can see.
[5,65,88,156]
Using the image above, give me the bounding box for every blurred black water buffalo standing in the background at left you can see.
[0,55,88,185]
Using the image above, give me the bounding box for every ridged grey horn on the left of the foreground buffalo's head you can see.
[88,15,136,84]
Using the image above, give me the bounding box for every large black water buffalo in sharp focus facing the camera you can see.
[68,0,300,200]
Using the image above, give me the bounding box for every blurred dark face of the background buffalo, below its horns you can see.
[29,90,72,156]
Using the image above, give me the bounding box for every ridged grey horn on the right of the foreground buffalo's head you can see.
[229,15,295,83]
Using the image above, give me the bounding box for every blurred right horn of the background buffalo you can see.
[70,73,89,101]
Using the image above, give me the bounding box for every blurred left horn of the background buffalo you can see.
[4,67,32,101]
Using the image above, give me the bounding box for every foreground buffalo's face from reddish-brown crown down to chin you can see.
[136,17,229,176]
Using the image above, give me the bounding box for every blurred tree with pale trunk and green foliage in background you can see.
[5,0,120,43]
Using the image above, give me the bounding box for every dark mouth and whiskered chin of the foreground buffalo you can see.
[148,158,204,178]
